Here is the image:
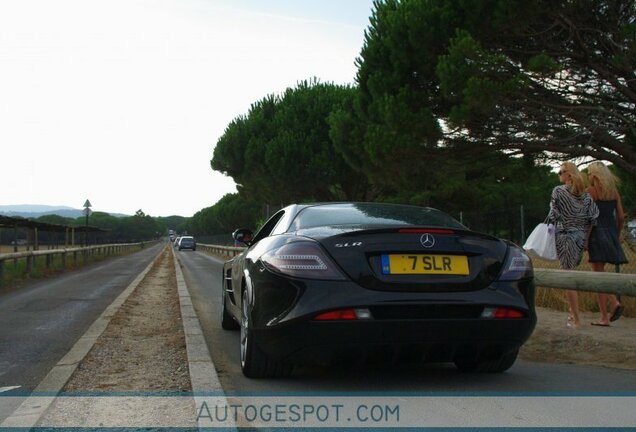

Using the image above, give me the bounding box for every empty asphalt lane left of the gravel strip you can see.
[0,244,165,392]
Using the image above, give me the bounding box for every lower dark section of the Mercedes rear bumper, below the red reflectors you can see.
[255,316,536,364]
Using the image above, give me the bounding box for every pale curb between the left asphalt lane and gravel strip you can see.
[0,245,163,428]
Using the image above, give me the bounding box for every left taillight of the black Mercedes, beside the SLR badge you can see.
[261,241,346,280]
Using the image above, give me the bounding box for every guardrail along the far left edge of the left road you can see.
[0,241,156,283]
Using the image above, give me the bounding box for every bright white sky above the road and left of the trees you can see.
[0,0,373,216]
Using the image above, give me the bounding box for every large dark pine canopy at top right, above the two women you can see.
[353,0,636,176]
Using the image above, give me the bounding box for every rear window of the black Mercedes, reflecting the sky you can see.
[290,203,466,231]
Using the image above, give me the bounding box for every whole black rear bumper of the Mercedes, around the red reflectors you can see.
[245,272,536,363]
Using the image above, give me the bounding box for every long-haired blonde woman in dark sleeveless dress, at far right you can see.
[587,162,627,327]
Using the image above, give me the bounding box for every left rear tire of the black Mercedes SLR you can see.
[240,290,292,378]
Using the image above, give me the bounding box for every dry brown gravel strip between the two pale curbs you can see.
[63,248,192,392]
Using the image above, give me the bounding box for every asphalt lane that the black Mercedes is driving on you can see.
[179,251,636,394]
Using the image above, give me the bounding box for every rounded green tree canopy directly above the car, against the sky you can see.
[211,80,366,204]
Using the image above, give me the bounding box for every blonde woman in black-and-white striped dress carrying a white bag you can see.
[548,162,599,328]
